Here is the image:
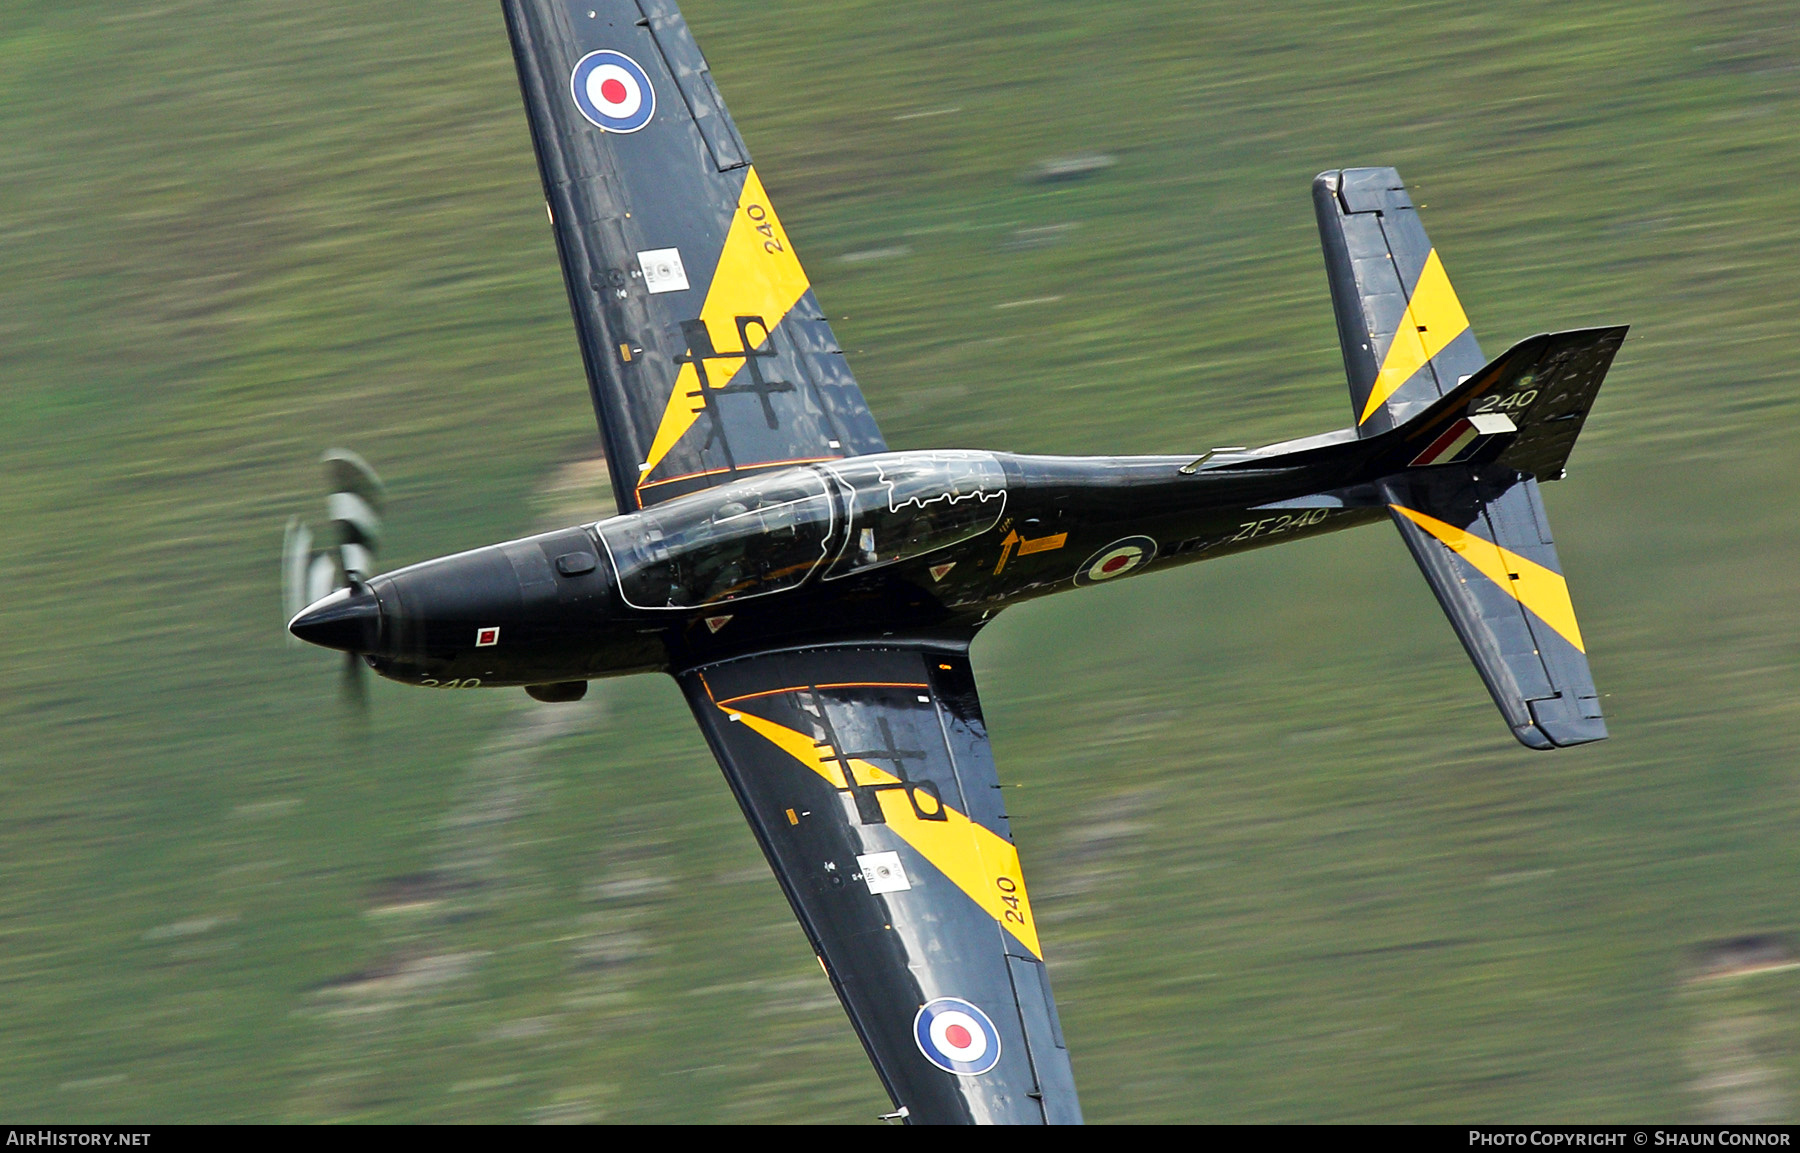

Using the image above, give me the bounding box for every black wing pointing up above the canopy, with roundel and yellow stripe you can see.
[504,0,886,511]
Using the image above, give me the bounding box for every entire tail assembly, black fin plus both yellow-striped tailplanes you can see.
[1260,167,1625,748]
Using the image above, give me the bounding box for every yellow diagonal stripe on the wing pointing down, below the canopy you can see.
[718,705,1044,957]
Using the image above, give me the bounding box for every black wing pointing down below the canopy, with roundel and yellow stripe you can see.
[680,646,1082,1124]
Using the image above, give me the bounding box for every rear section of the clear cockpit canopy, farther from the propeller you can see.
[826,451,1006,579]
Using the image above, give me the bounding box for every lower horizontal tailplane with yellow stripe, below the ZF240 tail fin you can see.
[1379,466,1606,748]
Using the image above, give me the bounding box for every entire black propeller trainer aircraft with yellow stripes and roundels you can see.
[290,0,1625,1122]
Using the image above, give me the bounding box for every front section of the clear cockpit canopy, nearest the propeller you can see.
[598,469,832,608]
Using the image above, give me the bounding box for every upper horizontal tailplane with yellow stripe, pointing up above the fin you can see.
[1312,167,1485,437]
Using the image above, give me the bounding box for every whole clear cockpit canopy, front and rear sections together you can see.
[596,451,1006,608]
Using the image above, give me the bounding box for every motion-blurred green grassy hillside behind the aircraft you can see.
[0,0,1800,1121]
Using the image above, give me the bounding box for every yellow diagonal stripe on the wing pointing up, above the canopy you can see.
[639,167,812,496]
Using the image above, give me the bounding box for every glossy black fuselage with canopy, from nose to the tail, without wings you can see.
[306,442,1382,689]
